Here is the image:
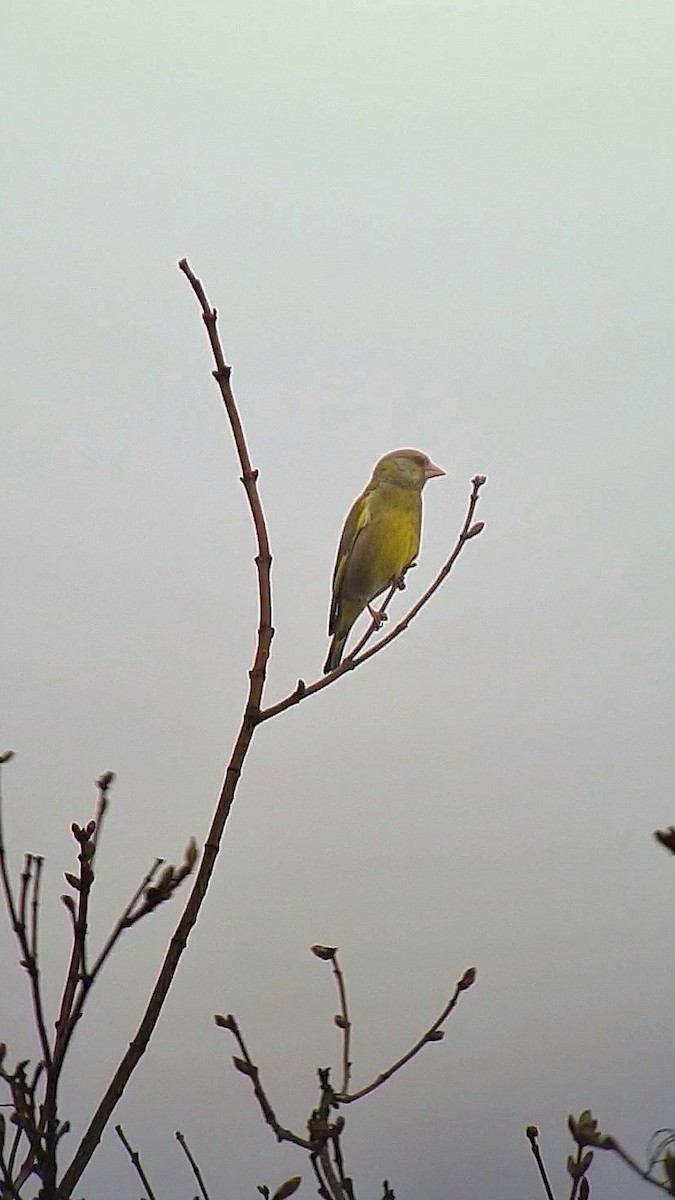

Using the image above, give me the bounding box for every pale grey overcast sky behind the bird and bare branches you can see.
[0,0,675,1200]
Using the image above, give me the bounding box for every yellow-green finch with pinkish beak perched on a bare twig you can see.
[323,450,446,674]
